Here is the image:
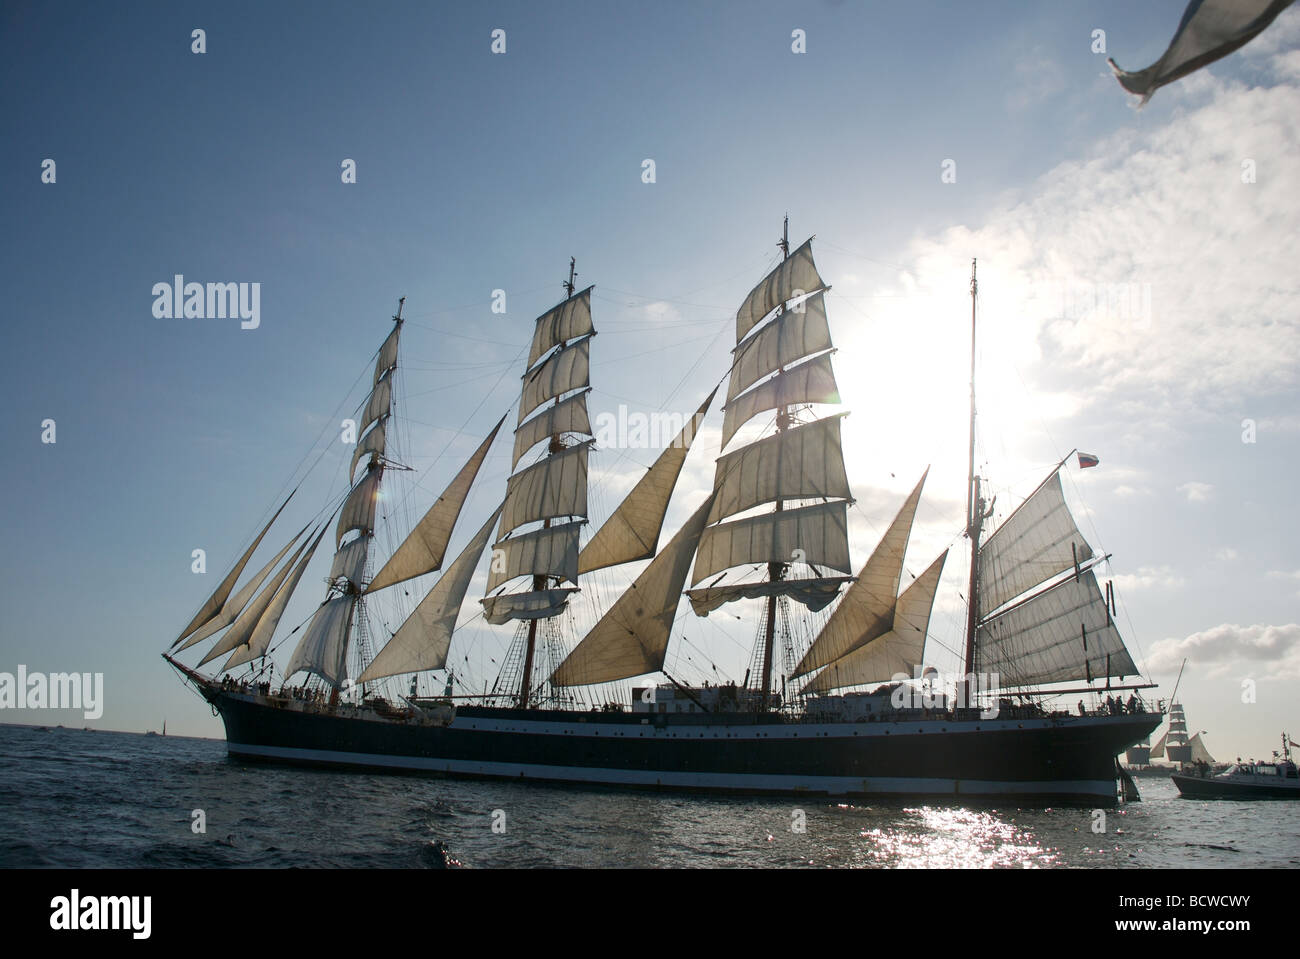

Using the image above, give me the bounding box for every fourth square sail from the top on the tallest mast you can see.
[709,415,853,522]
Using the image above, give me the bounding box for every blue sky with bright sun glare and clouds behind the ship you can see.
[0,0,1300,754]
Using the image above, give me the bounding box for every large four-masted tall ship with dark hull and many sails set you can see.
[164,218,1162,806]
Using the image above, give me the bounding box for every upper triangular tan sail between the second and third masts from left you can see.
[577,390,718,573]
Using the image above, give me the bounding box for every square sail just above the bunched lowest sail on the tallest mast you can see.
[690,500,849,586]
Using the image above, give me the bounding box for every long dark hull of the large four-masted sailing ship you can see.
[203,686,1161,806]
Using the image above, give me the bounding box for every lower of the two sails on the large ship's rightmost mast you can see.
[975,569,1138,686]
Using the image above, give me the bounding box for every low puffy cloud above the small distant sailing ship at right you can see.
[1148,622,1300,680]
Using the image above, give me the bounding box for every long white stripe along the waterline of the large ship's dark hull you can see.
[228,742,1115,802]
